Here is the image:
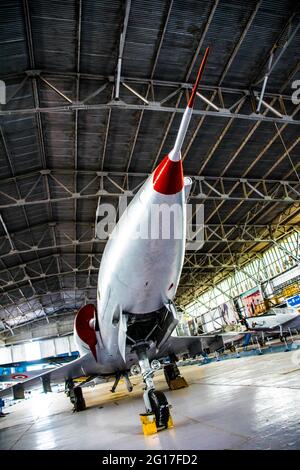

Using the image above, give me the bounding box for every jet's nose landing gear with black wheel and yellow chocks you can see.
[137,349,173,435]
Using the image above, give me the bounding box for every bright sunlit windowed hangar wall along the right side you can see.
[184,231,300,332]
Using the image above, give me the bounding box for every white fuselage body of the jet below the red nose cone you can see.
[97,175,186,370]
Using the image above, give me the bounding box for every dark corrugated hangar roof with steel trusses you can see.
[0,0,300,338]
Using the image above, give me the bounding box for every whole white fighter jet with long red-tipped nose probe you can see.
[0,48,223,427]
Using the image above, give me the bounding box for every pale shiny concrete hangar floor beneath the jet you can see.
[0,351,300,450]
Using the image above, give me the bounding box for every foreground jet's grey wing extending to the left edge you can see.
[0,353,100,397]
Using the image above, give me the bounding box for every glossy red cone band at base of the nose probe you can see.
[153,155,184,194]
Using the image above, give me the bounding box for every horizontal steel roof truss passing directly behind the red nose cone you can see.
[0,168,300,210]
